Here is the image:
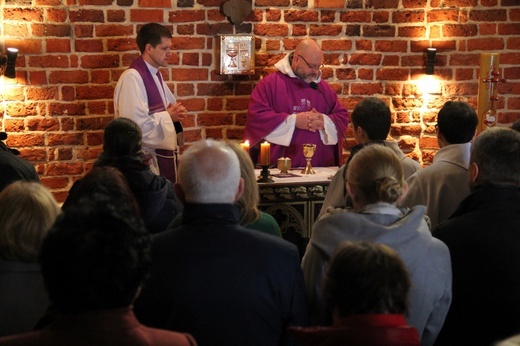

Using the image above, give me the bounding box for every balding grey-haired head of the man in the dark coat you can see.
[176,139,243,204]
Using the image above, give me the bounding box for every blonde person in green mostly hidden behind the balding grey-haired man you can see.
[168,142,282,237]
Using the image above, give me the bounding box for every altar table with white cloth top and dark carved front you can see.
[255,167,338,256]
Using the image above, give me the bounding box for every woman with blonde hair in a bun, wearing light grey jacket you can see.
[302,145,451,346]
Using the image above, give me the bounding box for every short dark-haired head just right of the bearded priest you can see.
[351,97,392,141]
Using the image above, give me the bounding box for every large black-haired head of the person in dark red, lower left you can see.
[40,193,150,313]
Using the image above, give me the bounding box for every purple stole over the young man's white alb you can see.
[130,56,177,183]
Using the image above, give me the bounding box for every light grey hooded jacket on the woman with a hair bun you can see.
[302,203,452,346]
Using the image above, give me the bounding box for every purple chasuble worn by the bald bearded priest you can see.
[244,71,349,167]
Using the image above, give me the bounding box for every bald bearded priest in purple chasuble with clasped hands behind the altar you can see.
[244,38,349,167]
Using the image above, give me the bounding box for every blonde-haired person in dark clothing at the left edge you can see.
[0,181,61,336]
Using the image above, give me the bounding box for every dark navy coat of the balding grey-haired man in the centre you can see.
[135,204,308,346]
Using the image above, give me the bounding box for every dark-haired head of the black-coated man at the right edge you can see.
[470,127,520,187]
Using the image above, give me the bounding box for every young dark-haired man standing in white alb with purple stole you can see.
[114,23,187,183]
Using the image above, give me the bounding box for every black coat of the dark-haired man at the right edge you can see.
[433,186,520,346]
